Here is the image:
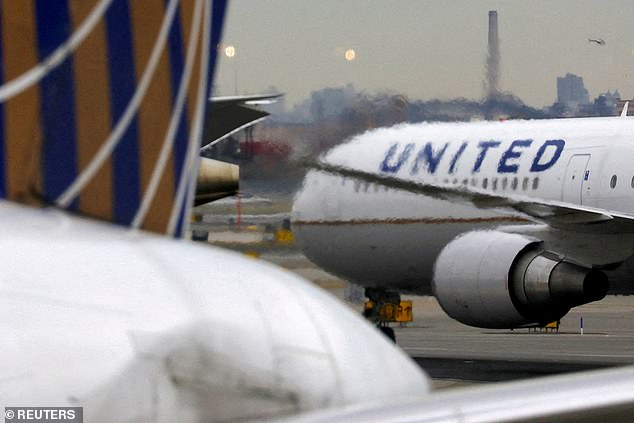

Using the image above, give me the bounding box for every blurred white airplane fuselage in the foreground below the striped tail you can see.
[0,202,428,422]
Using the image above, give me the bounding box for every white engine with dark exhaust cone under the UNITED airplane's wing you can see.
[432,231,608,329]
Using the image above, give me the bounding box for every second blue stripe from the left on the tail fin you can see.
[106,0,141,225]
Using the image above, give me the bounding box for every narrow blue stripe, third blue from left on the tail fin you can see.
[165,0,189,197]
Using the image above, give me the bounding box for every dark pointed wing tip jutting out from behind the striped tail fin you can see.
[202,94,283,147]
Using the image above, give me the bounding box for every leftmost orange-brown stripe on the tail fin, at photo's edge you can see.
[0,0,42,203]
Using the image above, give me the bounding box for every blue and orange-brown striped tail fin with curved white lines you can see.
[0,0,226,236]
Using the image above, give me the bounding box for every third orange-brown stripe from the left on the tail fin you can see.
[130,0,175,232]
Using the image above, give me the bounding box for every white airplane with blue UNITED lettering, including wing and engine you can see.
[292,109,634,329]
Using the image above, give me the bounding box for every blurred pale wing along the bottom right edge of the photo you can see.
[289,367,634,423]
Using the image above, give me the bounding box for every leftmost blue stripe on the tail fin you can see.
[35,0,78,210]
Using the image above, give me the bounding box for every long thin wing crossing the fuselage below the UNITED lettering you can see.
[308,161,634,231]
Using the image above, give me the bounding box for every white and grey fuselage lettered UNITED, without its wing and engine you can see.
[293,118,634,294]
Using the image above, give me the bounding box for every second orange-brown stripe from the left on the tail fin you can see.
[69,0,113,220]
